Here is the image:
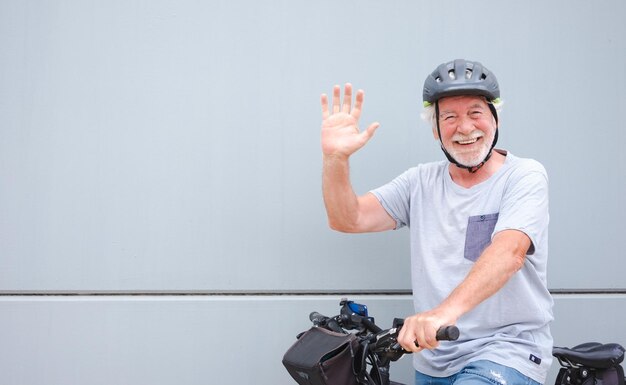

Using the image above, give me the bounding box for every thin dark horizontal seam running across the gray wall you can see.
[0,289,626,297]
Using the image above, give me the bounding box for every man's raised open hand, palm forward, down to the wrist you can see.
[321,83,380,158]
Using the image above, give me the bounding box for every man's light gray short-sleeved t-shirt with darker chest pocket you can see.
[372,153,553,383]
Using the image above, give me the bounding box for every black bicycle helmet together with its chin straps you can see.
[423,59,500,173]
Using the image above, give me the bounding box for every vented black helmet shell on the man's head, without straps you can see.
[423,59,500,106]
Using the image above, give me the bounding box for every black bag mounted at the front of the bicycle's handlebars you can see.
[283,326,359,385]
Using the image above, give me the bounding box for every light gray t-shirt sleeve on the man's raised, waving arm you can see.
[370,170,412,229]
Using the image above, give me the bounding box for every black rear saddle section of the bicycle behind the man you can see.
[552,342,625,385]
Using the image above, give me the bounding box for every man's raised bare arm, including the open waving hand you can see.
[321,84,396,233]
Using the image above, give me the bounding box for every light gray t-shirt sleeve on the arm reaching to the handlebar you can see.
[493,161,549,255]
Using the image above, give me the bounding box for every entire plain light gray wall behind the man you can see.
[0,0,626,384]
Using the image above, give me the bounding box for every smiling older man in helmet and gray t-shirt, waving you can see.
[321,59,553,385]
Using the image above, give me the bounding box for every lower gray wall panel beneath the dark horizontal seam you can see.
[0,295,626,385]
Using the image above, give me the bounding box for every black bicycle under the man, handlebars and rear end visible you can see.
[283,298,626,385]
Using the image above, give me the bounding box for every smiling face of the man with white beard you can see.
[435,96,496,167]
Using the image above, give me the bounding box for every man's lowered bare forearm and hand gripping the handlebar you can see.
[398,230,531,352]
